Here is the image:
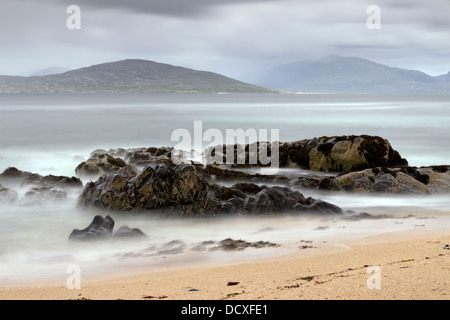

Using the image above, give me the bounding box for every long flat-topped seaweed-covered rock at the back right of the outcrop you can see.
[206,135,408,172]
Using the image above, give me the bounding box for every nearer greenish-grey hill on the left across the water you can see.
[0,59,271,93]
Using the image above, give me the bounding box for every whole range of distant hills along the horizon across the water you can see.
[0,55,450,94]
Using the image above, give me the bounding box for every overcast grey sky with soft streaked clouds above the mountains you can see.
[0,0,450,78]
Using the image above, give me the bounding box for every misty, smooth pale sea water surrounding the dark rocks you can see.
[0,94,450,285]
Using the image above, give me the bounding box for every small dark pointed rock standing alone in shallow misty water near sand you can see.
[69,215,114,241]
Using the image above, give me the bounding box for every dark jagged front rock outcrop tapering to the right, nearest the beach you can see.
[78,164,343,216]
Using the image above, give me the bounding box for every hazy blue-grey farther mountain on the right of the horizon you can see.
[252,55,450,94]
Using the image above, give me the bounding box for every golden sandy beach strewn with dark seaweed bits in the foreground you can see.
[0,228,450,300]
